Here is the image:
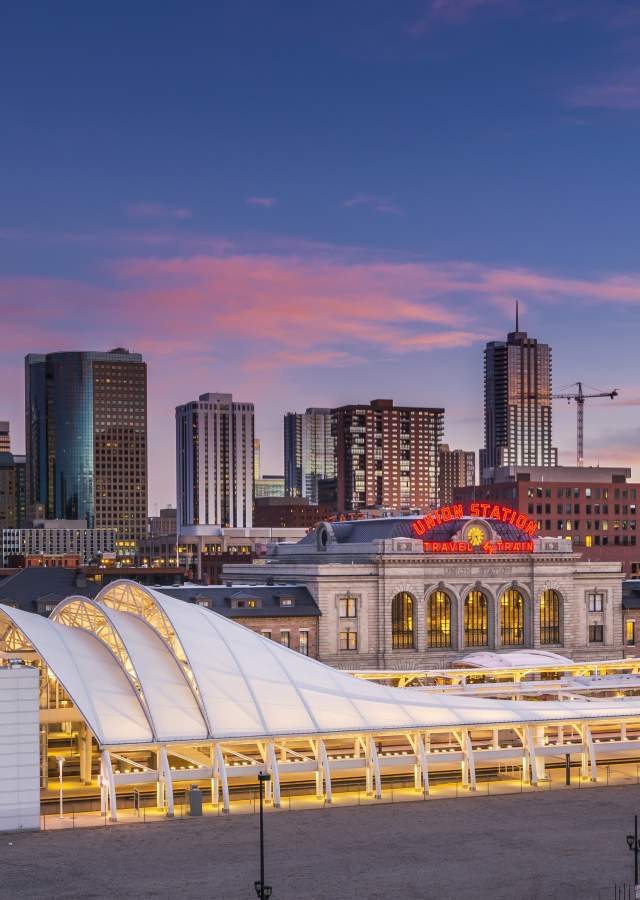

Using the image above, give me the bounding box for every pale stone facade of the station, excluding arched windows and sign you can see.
[225,520,624,668]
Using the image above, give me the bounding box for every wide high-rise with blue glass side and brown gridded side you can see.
[25,348,147,555]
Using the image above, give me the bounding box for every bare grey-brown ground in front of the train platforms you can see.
[0,785,640,900]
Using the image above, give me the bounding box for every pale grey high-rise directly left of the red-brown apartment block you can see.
[284,407,336,503]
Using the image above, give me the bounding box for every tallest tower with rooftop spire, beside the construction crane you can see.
[480,322,558,482]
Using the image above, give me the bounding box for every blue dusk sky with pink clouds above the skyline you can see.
[0,0,640,513]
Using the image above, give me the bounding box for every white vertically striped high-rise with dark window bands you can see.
[176,394,254,530]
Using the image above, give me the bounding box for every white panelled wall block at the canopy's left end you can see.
[0,666,40,831]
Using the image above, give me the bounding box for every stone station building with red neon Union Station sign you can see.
[224,503,624,669]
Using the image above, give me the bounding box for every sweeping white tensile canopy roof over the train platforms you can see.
[0,581,640,746]
